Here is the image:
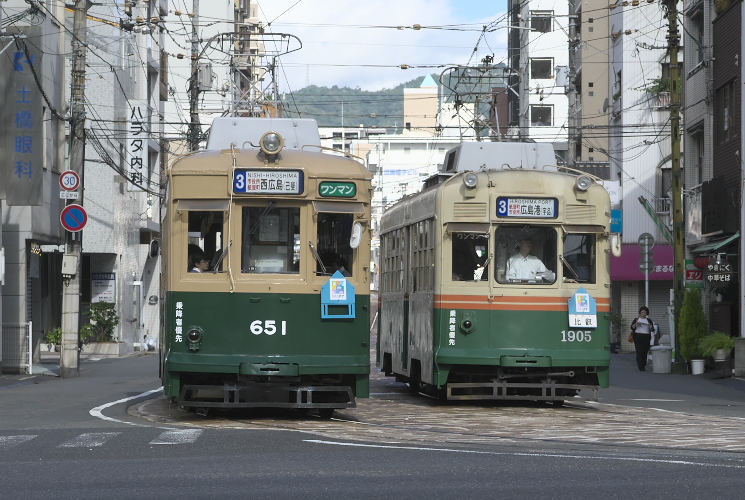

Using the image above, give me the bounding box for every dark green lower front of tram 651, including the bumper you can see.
[161,292,370,409]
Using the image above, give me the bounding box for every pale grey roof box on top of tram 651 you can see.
[206,116,321,151]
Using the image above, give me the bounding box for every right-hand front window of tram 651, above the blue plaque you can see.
[316,212,354,276]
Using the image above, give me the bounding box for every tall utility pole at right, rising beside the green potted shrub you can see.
[664,0,685,371]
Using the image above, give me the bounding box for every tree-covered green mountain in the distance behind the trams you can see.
[283,75,439,133]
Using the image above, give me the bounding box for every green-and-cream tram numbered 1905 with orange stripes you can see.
[377,143,620,405]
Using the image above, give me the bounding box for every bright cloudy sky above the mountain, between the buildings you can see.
[253,0,507,92]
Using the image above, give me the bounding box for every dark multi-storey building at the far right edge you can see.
[682,0,745,340]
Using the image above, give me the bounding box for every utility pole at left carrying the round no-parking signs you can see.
[60,0,93,378]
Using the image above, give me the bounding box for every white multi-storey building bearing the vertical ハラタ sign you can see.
[80,0,168,352]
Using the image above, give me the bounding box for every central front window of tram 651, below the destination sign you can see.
[241,203,301,274]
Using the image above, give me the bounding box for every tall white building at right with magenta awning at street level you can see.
[604,2,683,340]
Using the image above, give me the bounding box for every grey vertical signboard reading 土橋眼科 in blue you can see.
[0,26,44,206]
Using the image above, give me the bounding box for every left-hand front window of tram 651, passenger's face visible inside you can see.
[186,211,225,273]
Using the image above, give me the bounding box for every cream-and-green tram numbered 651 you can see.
[160,118,372,417]
